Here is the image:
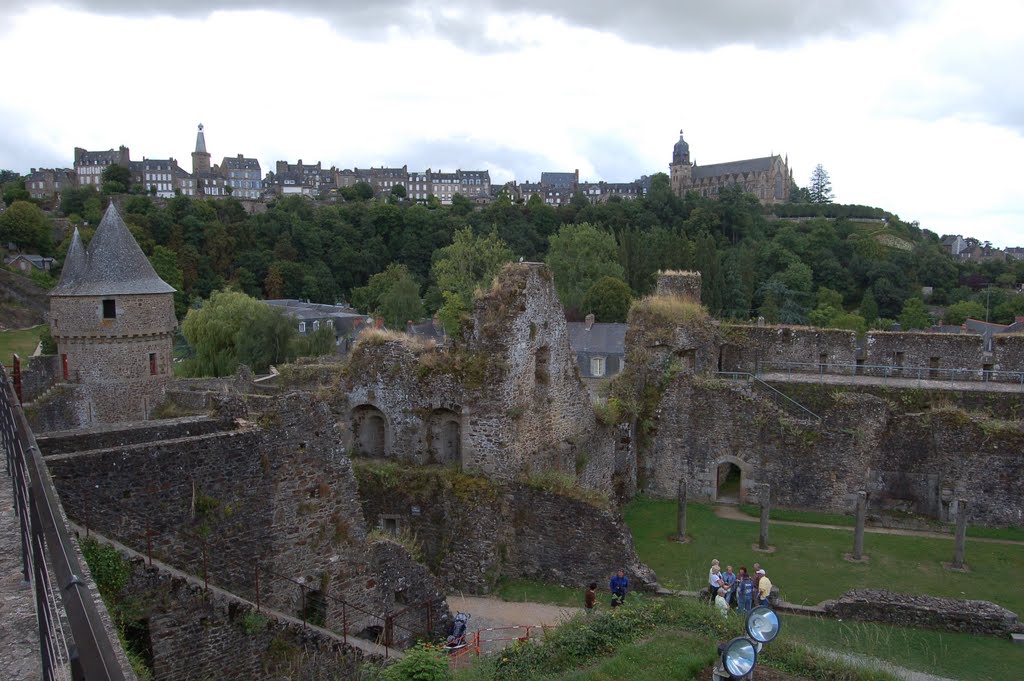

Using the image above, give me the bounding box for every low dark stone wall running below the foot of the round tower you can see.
[36,417,233,456]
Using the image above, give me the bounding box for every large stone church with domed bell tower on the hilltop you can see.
[669,130,793,204]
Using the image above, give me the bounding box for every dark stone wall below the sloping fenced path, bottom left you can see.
[125,558,365,681]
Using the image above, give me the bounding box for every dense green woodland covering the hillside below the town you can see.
[0,169,1024,337]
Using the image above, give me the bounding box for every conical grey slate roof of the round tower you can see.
[53,202,174,296]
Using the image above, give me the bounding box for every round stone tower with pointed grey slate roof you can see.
[50,202,177,423]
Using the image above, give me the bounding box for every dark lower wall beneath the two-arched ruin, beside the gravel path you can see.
[358,467,654,593]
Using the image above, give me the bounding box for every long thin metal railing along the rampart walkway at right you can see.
[755,361,1024,387]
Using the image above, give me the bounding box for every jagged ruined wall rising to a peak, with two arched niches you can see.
[339,263,612,490]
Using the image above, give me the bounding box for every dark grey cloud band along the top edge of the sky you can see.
[4,0,928,51]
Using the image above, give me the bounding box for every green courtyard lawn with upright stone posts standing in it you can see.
[626,498,1024,613]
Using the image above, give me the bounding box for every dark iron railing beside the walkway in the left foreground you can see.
[0,355,126,681]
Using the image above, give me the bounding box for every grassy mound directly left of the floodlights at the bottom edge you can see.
[557,631,717,681]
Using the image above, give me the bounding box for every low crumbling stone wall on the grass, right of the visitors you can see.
[825,589,1024,636]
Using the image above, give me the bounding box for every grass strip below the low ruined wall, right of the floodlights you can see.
[779,615,1024,681]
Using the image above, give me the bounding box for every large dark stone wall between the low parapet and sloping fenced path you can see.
[46,395,447,638]
